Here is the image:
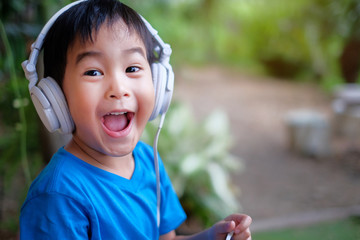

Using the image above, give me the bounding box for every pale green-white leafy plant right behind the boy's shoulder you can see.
[143,103,241,226]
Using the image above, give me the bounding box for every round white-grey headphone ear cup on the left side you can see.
[30,77,74,134]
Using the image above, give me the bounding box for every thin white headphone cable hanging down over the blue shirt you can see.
[153,113,166,227]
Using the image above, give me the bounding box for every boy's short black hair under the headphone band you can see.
[43,0,155,87]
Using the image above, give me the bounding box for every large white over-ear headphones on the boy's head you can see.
[22,0,174,134]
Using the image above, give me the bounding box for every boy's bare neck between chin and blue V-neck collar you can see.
[65,135,135,179]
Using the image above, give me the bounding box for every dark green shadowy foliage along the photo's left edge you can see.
[0,1,67,233]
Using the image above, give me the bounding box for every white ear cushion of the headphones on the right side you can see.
[149,63,167,121]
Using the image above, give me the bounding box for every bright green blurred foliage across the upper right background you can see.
[125,0,360,89]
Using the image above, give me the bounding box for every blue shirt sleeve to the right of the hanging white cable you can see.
[159,161,186,235]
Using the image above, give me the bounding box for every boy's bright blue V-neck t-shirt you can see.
[20,142,186,240]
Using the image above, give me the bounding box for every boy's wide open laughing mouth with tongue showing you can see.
[102,112,134,132]
